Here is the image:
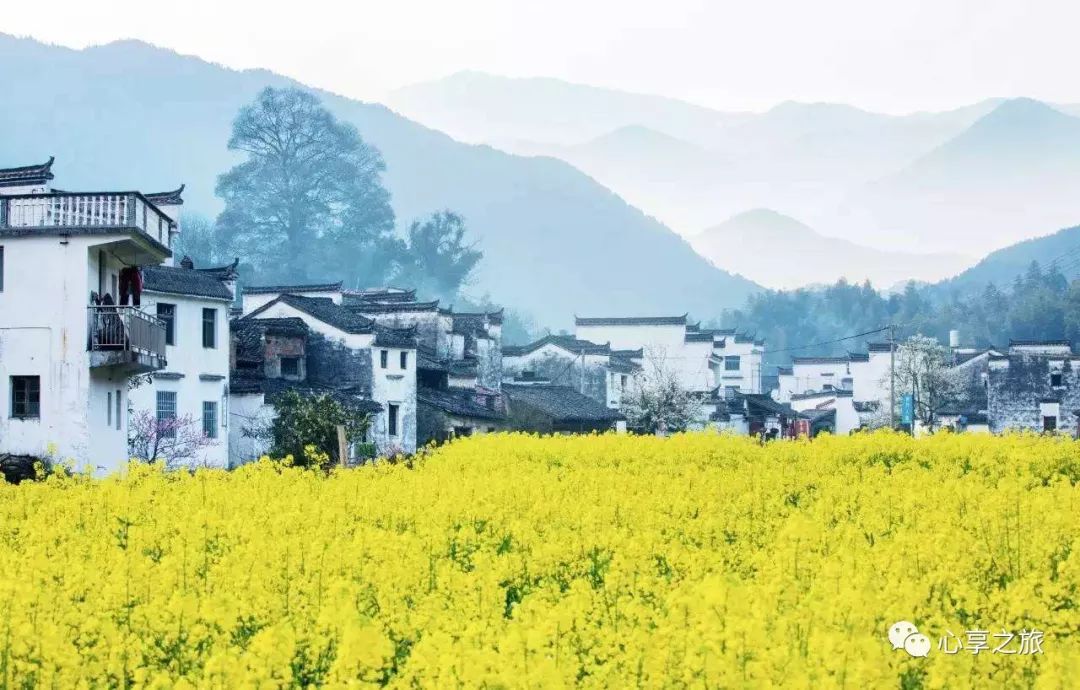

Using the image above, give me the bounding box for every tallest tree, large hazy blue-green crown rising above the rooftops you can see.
[217,87,396,282]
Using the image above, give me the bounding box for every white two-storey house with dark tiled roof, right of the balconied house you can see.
[131,257,237,468]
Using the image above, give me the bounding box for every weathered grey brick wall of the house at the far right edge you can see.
[987,354,1080,433]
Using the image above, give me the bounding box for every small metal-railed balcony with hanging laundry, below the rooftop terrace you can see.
[86,306,165,374]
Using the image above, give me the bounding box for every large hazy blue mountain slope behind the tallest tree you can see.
[0,35,759,327]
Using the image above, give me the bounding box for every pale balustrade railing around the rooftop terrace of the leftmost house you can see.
[0,192,173,247]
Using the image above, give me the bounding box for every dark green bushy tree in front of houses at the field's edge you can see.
[262,391,370,466]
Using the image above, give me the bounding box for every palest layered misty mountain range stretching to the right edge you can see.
[387,72,1080,287]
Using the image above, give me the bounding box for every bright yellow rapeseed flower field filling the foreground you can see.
[0,433,1080,690]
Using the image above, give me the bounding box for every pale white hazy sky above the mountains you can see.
[8,0,1080,112]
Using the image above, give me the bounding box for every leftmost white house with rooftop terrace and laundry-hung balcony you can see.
[0,159,176,471]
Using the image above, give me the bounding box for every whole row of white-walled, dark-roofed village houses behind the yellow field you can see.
[0,159,1080,470]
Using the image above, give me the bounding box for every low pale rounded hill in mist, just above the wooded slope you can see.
[691,208,971,289]
